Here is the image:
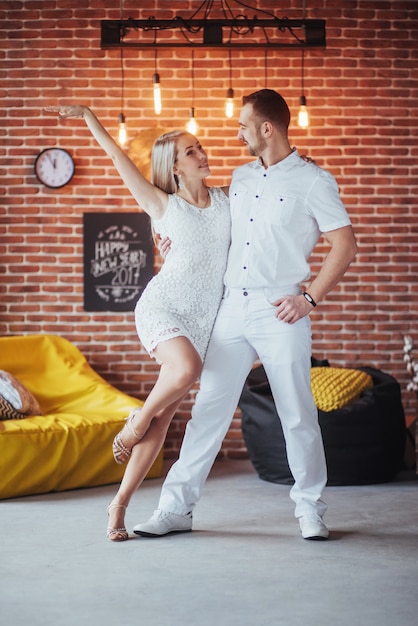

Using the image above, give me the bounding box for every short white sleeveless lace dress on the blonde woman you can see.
[135,187,231,360]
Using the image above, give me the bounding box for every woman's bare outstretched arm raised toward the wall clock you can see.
[45,105,168,219]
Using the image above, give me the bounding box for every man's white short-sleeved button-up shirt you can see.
[224,151,350,302]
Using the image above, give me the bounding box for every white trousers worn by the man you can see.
[158,289,327,517]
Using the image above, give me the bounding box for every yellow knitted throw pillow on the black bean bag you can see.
[311,367,373,411]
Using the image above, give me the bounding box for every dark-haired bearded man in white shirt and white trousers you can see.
[134,89,356,539]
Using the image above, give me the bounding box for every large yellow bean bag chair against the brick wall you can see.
[0,335,163,499]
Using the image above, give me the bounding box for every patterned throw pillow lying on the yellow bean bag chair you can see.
[0,370,42,420]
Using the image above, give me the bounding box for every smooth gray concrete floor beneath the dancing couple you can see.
[0,461,418,626]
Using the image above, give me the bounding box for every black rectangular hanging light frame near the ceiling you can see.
[101,16,326,49]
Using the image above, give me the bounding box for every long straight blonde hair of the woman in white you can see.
[151,130,187,193]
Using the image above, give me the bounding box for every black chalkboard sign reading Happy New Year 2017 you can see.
[84,213,154,311]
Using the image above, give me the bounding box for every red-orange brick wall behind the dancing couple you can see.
[0,0,418,457]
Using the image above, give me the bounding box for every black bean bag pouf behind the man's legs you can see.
[239,363,406,485]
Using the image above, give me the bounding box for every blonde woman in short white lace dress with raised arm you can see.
[47,105,230,541]
